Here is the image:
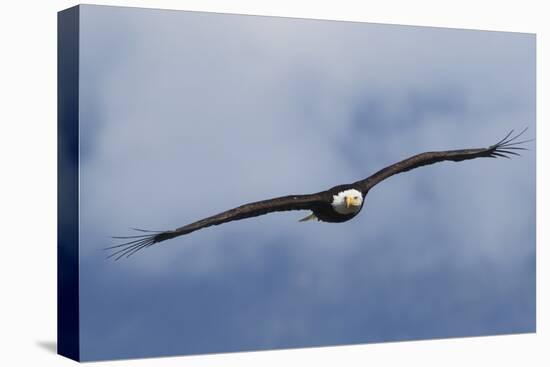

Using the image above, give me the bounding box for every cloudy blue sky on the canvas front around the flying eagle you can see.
[76,5,535,360]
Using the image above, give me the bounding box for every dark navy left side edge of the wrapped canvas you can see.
[57,6,80,361]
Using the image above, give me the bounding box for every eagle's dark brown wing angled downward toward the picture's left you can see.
[105,193,323,260]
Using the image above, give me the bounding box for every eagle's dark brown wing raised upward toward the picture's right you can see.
[352,128,531,195]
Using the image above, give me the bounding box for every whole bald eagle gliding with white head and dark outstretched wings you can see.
[106,128,531,260]
